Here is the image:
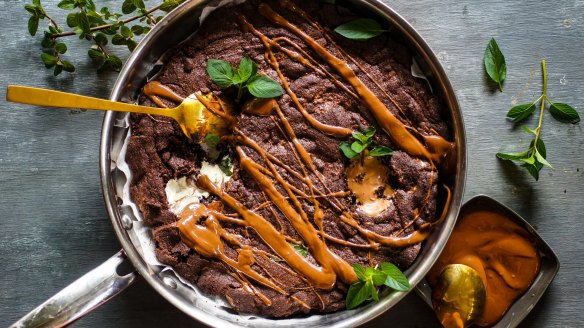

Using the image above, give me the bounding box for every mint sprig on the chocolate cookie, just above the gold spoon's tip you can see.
[207,55,284,102]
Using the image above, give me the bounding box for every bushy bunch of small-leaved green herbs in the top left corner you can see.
[24,0,185,76]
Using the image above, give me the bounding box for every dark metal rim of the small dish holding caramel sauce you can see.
[416,195,560,328]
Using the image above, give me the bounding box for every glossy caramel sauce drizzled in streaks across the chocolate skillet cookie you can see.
[144,0,454,309]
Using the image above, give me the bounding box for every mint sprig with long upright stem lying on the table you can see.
[497,59,580,181]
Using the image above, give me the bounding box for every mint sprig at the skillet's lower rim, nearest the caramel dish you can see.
[345,262,410,310]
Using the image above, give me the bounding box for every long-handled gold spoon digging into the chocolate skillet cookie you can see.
[6,85,228,138]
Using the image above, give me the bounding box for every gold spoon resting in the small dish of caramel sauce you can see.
[432,264,486,328]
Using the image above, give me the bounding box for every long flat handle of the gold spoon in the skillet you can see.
[6,85,176,119]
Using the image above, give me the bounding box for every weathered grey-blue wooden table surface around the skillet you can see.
[0,0,584,328]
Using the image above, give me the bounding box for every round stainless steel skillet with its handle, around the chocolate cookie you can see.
[9,0,466,328]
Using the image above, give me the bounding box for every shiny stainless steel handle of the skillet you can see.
[10,251,138,328]
